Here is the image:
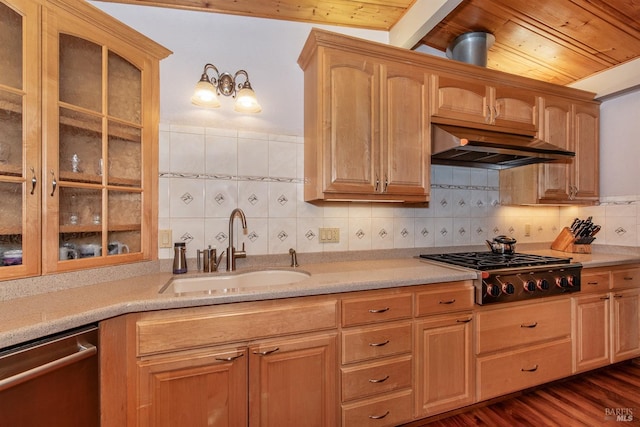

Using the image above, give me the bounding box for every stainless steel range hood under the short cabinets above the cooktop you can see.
[431,123,575,169]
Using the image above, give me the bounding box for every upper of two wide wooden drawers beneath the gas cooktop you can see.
[476,298,571,354]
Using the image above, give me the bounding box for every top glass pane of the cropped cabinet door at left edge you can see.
[0,3,22,89]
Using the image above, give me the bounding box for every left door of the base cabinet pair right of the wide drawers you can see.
[573,293,611,372]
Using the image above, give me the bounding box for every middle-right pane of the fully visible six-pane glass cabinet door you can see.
[107,121,142,188]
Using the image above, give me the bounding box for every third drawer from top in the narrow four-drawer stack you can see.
[341,356,412,402]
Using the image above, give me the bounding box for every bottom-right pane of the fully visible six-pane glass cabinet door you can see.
[107,191,142,255]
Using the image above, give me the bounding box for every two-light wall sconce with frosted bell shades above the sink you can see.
[191,64,262,113]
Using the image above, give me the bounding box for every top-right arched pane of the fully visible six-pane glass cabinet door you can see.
[107,52,142,124]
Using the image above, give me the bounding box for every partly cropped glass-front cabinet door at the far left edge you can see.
[0,1,41,279]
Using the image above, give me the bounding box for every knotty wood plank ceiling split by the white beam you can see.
[100,0,640,85]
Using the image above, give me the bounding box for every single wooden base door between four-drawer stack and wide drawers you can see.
[415,313,475,418]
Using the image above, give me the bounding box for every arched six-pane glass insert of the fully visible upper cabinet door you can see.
[44,30,145,272]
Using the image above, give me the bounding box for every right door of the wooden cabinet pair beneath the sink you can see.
[249,334,338,427]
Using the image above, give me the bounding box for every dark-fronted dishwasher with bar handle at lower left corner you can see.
[0,326,100,427]
